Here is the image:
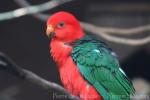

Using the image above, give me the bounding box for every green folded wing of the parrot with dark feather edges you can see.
[72,36,134,100]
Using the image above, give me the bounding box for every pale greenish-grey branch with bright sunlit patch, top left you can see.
[0,0,70,21]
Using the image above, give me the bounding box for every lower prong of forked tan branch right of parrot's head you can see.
[81,22,150,46]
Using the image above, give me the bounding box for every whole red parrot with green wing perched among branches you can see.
[46,11,135,100]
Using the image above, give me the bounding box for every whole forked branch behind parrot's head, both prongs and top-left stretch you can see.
[15,0,150,46]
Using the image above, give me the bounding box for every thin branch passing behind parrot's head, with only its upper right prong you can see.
[14,0,150,35]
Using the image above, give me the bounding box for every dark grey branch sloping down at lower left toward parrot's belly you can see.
[0,52,79,100]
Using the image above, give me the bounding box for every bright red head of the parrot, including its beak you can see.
[46,11,84,42]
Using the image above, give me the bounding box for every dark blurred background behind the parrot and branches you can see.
[0,0,150,100]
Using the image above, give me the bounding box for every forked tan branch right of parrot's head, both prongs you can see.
[81,22,150,46]
